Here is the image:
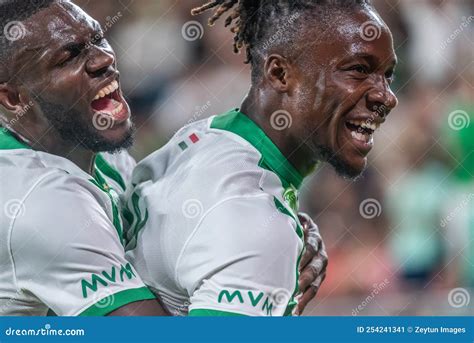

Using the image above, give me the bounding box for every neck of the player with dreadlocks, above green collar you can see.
[241,89,318,176]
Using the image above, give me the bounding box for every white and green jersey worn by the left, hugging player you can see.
[0,129,154,316]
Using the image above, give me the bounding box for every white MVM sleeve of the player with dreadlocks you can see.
[177,196,302,316]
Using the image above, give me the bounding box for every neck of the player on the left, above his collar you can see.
[12,126,96,175]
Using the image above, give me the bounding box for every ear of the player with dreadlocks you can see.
[264,54,292,93]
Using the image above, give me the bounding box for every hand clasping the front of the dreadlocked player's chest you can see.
[295,213,328,315]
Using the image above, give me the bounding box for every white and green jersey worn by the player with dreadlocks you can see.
[126,111,303,316]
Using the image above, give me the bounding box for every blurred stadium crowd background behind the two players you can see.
[76,0,474,316]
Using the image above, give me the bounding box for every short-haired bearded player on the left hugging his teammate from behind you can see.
[0,0,164,316]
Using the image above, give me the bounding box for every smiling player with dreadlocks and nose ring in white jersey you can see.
[128,0,397,316]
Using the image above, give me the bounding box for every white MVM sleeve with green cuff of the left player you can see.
[11,173,154,316]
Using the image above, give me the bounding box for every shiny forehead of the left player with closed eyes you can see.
[23,2,98,44]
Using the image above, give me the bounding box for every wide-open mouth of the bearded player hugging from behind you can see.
[91,80,129,122]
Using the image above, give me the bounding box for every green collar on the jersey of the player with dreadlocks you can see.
[211,109,303,188]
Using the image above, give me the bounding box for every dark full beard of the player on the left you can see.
[36,97,135,153]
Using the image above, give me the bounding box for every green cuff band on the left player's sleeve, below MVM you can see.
[79,287,156,317]
